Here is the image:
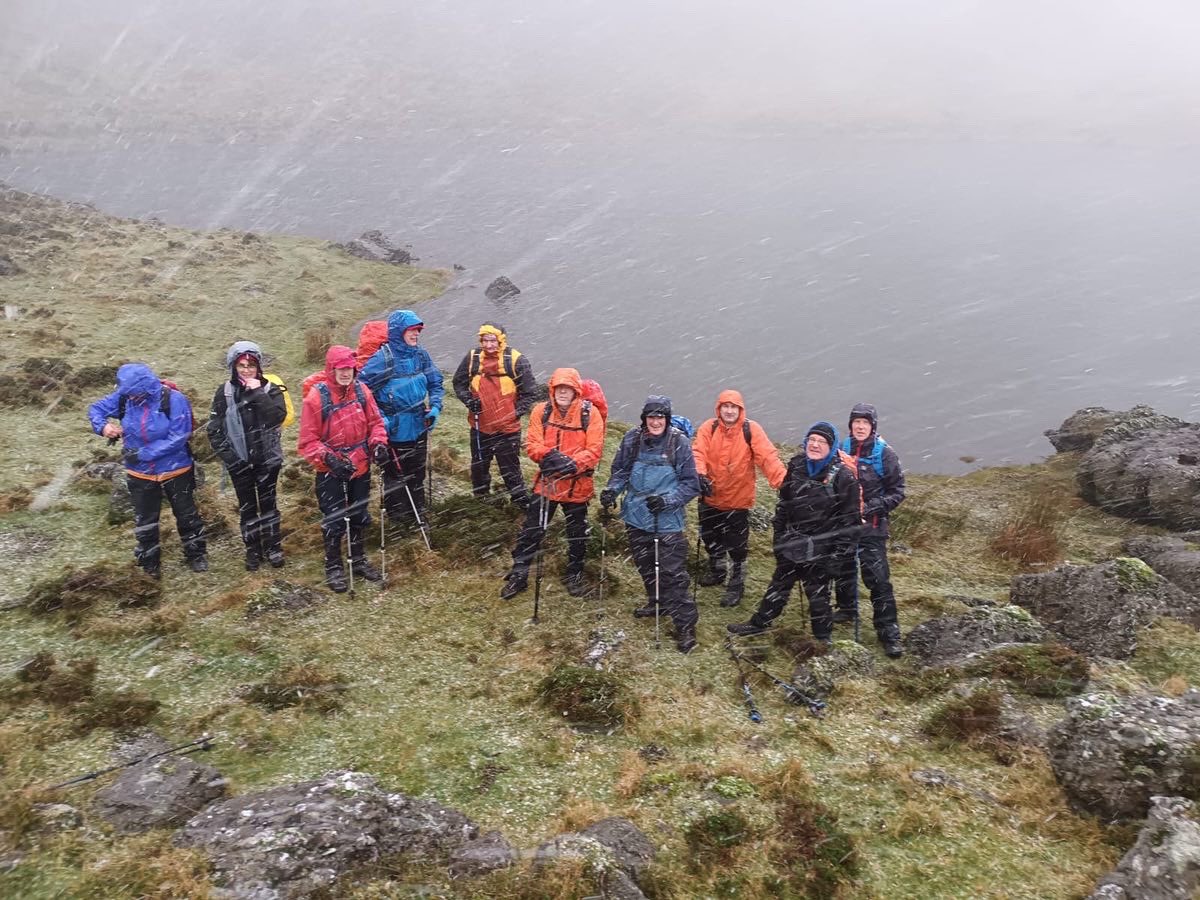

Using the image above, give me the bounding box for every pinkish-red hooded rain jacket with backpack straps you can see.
[298,347,388,478]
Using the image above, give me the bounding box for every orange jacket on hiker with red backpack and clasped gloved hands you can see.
[526,368,604,503]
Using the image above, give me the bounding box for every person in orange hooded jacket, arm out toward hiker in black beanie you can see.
[691,390,787,606]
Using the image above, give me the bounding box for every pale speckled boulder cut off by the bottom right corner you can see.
[1087,797,1200,900]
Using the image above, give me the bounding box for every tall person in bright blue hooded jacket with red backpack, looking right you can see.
[359,310,445,522]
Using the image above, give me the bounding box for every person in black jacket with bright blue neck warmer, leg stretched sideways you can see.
[726,422,862,644]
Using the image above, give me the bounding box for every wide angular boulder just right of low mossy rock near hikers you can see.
[1009,557,1200,659]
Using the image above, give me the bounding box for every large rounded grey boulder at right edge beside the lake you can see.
[1075,407,1200,530]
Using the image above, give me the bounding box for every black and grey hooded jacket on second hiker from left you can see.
[208,341,288,468]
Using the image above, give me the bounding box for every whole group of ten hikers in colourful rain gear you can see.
[88,310,905,658]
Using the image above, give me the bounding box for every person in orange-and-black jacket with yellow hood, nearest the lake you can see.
[454,322,538,508]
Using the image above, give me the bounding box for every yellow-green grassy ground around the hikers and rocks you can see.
[0,187,1200,898]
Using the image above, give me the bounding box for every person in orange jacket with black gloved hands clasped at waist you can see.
[500,368,605,600]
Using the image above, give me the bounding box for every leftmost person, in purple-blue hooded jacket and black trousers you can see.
[88,362,209,578]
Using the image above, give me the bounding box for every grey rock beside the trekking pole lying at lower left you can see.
[95,751,226,834]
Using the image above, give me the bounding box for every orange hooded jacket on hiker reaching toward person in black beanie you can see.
[691,390,787,510]
